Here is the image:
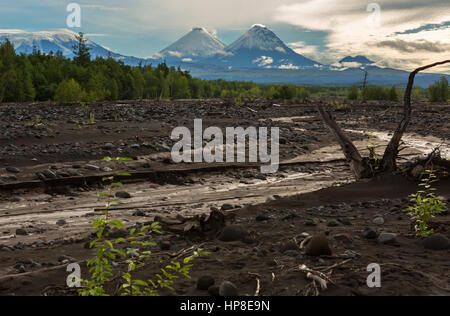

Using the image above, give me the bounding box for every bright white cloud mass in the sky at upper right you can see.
[274,0,450,69]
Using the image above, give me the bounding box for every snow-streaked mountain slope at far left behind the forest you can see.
[0,29,146,65]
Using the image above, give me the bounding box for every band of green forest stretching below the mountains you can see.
[0,33,448,104]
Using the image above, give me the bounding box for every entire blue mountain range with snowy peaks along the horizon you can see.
[0,24,449,86]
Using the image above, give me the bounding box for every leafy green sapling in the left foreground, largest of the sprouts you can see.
[78,157,209,296]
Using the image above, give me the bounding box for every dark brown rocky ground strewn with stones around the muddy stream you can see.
[0,100,450,296]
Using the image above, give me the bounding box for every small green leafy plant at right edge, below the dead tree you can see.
[405,170,446,237]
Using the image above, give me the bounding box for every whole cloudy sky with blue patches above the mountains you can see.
[0,0,450,73]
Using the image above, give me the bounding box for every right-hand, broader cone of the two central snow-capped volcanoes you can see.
[205,24,320,69]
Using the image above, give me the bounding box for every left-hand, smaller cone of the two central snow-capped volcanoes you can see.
[155,27,229,61]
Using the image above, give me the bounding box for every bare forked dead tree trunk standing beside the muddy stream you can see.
[318,60,450,180]
